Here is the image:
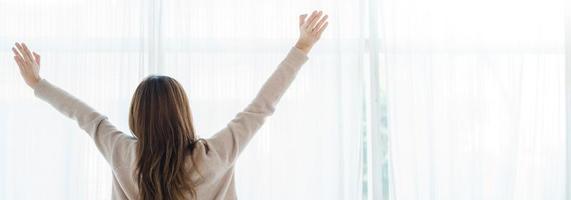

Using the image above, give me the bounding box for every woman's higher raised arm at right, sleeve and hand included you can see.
[207,11,328,165]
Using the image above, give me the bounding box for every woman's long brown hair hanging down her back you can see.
[129,76,197,200]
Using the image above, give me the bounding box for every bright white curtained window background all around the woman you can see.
[0,0,571,200]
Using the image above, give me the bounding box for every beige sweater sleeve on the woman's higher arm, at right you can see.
[207,47,308,165]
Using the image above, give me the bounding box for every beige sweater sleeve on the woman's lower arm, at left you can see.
[34,79,135,168]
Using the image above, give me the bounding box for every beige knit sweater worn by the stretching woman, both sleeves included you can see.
[34,48,308,200]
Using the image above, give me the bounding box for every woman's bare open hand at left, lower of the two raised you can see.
[12,43,42,88]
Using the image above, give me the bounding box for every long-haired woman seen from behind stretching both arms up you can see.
[12,11,328,200]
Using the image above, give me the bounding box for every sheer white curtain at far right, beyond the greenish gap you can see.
[381,0,566,200]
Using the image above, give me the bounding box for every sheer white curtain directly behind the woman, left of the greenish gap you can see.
[0,0,368,200]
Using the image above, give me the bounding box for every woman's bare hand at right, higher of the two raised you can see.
[295,11,329,54]
